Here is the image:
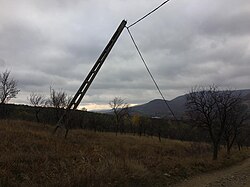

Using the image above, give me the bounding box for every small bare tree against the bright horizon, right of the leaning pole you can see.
[109,97,129,135]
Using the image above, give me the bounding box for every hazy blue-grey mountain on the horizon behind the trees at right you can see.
[130,89,250,118]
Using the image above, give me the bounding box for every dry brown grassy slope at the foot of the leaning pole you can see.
[0,121,247,186]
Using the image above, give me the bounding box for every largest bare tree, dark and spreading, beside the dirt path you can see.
[186,85,246,160]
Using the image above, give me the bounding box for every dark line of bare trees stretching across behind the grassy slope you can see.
[0,70,250,159]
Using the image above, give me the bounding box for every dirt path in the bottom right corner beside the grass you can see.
[173,159,250,187]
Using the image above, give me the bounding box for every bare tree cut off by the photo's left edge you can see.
[0,70,20,104]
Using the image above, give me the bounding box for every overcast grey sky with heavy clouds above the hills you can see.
[0,0,250,109]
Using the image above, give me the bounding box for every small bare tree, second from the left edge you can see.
[28,93,46,123]
